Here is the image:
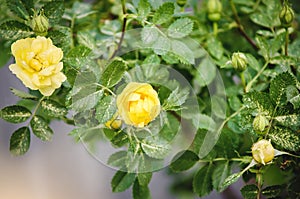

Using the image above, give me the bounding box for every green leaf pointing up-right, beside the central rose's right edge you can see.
[163,87,189,110]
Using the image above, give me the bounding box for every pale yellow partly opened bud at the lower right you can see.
[252,140,275,165]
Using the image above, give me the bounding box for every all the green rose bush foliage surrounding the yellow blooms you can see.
[0,0,300,199]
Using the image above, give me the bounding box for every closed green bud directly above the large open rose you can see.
[31,11,49,36]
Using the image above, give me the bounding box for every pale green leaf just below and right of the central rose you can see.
[141,138,170,159]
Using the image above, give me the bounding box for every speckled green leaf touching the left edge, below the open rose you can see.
[0,105,31,123]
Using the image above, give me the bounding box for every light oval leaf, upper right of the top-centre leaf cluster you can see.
[168,18,194,38]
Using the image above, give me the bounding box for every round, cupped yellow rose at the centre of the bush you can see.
[117,82,160,127]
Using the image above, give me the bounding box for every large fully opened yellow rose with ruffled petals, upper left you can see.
[9,36,66,96]
